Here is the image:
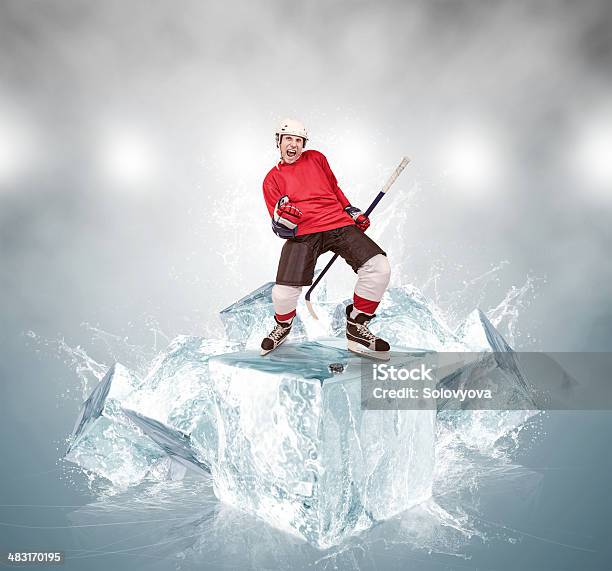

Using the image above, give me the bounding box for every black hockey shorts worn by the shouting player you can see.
[276,225,387,286]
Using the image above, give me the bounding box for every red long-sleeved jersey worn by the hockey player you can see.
[263,150,354,236]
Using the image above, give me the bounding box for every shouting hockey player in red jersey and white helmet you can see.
[261,119,391,359]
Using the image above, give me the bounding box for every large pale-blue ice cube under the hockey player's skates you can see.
[209,340,436,547]
